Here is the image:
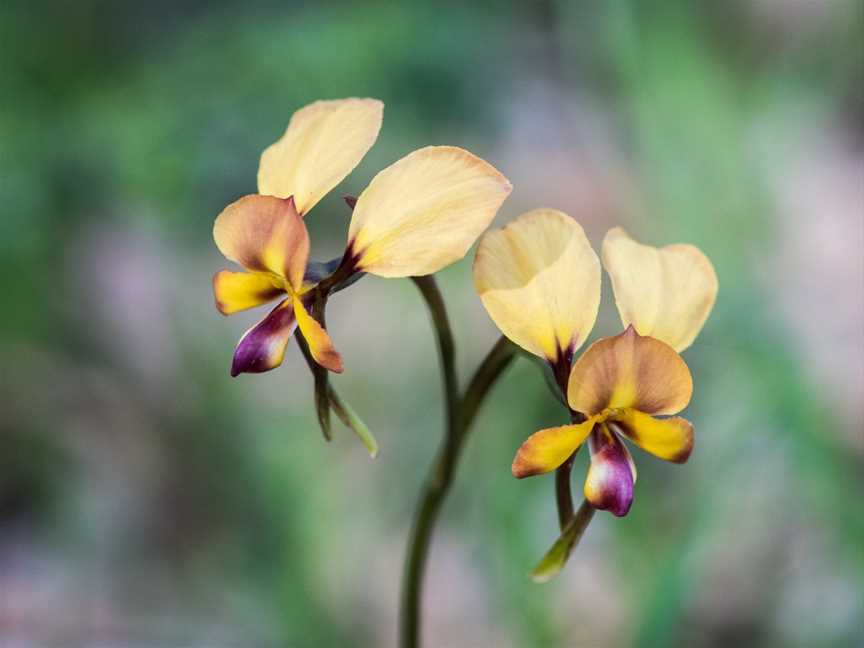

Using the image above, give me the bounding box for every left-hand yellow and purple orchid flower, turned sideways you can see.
[213,99,511,376]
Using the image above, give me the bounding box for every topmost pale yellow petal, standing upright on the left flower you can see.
[258,99,384,215]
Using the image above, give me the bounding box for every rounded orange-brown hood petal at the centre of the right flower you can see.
[567,326,693,416]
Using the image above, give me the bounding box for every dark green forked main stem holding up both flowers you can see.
[399,276,515,648]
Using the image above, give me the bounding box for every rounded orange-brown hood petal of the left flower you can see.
[213,195,309,290]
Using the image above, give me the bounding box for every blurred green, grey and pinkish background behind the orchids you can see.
[0,0,864,648]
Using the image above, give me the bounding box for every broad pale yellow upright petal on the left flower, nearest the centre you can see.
[348,146,512,277]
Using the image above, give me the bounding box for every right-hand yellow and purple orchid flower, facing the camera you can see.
[474,209,718,516]
